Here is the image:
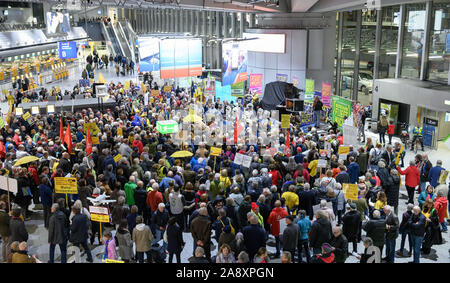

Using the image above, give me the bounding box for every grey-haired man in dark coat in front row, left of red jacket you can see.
[242,212,266,262]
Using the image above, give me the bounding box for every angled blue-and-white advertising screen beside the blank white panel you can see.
[222,42,247,86]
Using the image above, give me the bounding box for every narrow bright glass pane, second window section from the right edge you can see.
[401,3,426,79]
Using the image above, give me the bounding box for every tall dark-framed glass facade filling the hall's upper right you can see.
[334,0,450,105]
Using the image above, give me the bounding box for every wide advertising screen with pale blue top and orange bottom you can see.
[160,38,202,79]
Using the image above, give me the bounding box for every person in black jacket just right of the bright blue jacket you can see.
[309,210,332,255]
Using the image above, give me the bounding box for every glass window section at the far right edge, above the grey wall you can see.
[428,1,450,84]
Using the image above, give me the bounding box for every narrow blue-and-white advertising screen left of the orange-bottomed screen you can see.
[137,37,159,72]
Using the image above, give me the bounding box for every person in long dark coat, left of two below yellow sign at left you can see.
[48,203,67,263]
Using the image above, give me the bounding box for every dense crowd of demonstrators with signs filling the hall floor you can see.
[0,71,449,263]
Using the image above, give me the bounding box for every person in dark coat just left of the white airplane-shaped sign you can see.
[70,206,93,262]
